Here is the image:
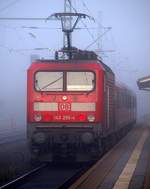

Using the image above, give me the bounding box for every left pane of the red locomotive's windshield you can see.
[35,71,63,91]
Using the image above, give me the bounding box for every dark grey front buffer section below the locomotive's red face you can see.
[28,124,102,162]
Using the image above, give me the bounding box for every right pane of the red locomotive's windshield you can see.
[67,72,95,91]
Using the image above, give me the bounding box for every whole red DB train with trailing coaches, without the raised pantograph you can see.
[27,52,136,161]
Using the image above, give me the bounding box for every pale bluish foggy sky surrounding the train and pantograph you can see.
[0,0,150,131]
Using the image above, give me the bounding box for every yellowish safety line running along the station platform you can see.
[113,130,148,189]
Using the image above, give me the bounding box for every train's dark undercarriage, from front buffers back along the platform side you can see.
[28,122,134,162]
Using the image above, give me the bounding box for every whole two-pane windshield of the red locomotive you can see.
[35,71,95,91]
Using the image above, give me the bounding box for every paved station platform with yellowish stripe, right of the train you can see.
[69,126,150,189]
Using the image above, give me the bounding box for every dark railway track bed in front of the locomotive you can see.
[0,164,91,189]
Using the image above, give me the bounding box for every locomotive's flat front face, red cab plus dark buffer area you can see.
[28,62,103,160]
